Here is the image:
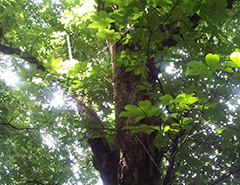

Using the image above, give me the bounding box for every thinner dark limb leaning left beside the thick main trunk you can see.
[76,98,118,185]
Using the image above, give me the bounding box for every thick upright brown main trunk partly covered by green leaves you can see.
[113,47,161,185]
